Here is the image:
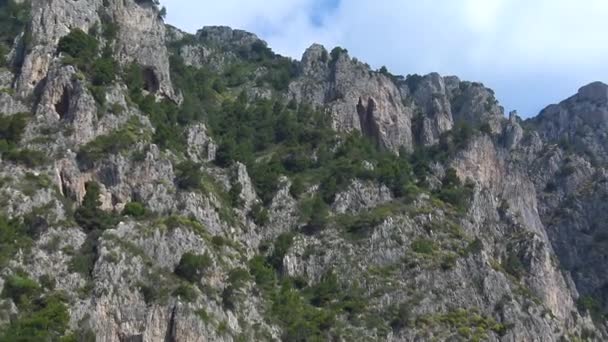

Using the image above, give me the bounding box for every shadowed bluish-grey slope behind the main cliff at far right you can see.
[529,82,608,314]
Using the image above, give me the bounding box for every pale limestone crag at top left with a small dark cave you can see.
[16,0,179,101]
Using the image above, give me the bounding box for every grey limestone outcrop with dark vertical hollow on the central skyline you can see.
[289,45,413,152]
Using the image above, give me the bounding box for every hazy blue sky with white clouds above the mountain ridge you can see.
[161,0,608,117]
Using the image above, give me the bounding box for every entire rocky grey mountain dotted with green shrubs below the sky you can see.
[0,0,608,342]
